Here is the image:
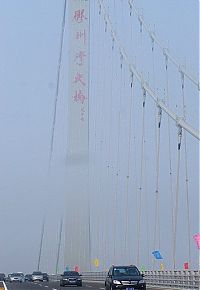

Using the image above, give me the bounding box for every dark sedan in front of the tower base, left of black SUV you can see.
[60,271,82,287]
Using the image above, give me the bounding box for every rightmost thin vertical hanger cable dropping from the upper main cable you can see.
[181,72,191,265]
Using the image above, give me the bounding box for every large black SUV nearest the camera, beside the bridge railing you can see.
[105,265,146,290]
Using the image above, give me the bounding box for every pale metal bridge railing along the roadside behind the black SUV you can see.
[82,270,200,289]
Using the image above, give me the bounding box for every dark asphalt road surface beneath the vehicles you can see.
[6,282,158,290]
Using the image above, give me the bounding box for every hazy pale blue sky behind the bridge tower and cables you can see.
[0,0,199,273]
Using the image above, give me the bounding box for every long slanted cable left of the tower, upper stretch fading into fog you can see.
[49,0,66,170]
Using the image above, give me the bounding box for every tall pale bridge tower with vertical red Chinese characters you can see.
[65,0,90,271]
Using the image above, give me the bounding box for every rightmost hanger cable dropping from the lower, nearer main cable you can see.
[173,126,182,270]
